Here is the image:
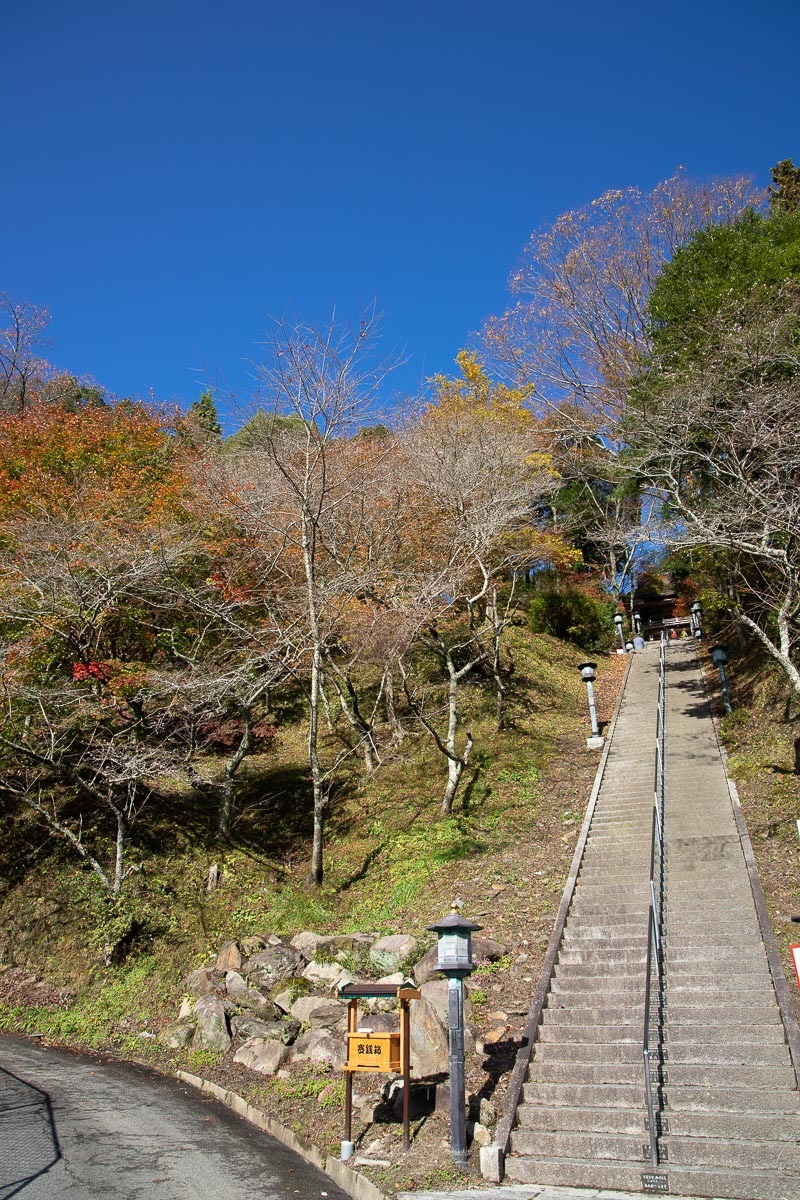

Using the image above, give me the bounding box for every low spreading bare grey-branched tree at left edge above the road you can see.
[0,494,194,895]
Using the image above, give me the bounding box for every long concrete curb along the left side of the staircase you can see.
[481,654,633,1183]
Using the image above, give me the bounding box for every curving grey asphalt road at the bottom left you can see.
[0,1038,348,1200]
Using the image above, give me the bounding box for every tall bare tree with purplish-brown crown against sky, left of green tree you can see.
[481,169,765,598]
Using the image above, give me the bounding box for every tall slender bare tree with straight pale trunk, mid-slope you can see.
[221,311,397,883]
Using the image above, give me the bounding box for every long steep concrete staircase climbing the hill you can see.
[505,643,800,1200]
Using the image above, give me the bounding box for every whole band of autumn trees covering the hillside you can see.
[0,160,800,979]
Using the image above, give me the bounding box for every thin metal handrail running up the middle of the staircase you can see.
[642,635,667,1166]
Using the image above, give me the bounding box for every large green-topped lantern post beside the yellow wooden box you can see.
[428,905,483,1171]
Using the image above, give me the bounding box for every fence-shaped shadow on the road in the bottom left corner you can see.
[0,1067,61,1200]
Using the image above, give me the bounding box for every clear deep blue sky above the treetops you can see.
[0,0,800,424]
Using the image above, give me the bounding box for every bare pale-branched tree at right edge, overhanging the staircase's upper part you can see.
[631,284,800,696]
